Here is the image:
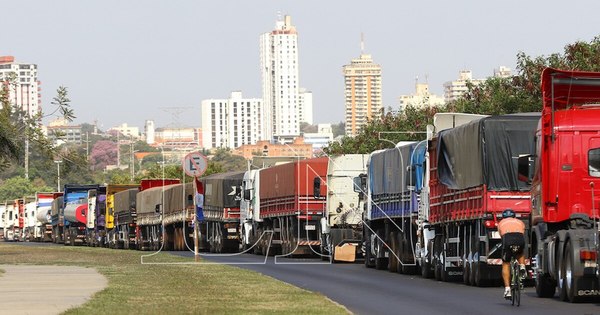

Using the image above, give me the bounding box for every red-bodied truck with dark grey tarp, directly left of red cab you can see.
[417,113,540,286]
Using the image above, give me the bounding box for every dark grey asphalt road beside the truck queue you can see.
[171,252,600,315]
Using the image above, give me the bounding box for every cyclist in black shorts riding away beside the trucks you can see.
[498,209,527,299]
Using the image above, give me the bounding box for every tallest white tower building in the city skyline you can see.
[260,15,301,141]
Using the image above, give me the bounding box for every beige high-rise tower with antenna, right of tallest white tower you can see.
[344,53,383,136]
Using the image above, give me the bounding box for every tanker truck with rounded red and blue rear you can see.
[63,184,103,245]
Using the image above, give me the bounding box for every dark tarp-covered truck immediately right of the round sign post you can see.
[200,172,245,253]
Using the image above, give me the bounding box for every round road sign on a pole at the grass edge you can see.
[182,152,208,261]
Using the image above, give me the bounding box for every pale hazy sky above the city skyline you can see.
[0,0,600,130]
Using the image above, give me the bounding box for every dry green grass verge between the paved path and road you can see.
[0,243,348,315]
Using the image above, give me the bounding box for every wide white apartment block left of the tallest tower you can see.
[202,91,265,149]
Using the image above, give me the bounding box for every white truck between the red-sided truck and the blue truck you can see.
[321,154,369,262]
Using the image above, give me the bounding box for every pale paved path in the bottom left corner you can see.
[0,265,108,315]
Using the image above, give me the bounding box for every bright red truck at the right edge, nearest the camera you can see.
[519,68,600,302]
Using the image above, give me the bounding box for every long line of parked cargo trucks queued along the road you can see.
[0,68,600,302]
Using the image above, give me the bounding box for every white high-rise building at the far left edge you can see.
[0,56,42,116]
